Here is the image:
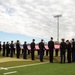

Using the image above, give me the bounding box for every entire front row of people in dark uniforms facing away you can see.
[0,37,75,63]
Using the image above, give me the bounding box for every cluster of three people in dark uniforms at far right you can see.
[60,38,75,63]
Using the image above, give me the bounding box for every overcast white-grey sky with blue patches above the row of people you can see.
[0,0,75,43]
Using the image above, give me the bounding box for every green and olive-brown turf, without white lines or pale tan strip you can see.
[0,50,75,75]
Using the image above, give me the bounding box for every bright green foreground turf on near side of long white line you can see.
[0,63,75,75]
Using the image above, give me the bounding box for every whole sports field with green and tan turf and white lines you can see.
[0,51,75,75]
